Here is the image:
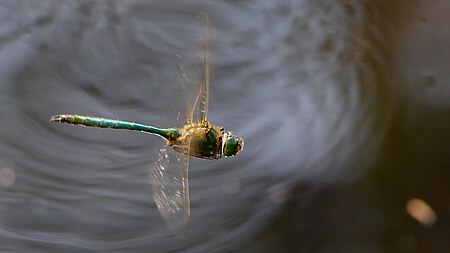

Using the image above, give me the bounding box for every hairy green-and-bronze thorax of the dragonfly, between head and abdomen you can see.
[167,121,224,159]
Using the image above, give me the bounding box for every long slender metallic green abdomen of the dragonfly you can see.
[50,114,181,140]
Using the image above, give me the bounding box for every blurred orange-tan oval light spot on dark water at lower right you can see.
[406,198,436,227]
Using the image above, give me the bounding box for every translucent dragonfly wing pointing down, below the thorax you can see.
[149,147,190,237]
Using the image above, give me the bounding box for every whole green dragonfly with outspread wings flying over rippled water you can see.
[50,13,244,237]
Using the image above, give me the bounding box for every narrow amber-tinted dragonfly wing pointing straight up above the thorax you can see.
[188,12,210,123]
